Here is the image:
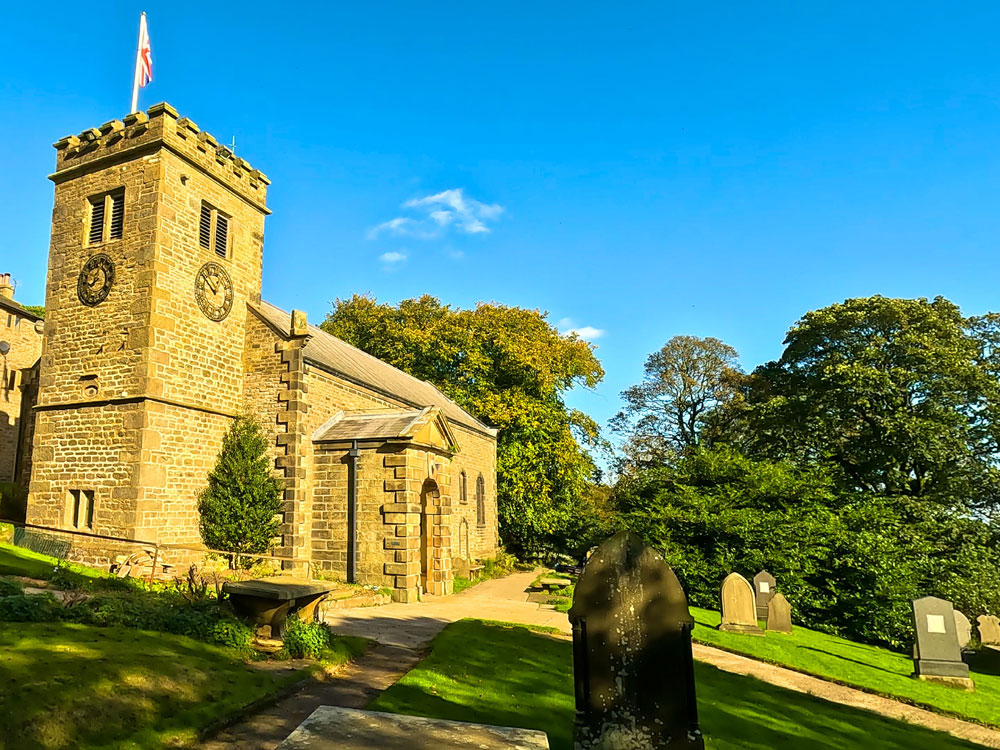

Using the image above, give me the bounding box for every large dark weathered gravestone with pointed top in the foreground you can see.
[569,531,705,750]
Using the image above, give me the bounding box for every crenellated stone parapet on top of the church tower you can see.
[49,102,271,210]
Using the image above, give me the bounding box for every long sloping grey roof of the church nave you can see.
[251,301,496,436]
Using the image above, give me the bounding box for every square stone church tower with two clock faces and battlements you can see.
[27,104,270,562]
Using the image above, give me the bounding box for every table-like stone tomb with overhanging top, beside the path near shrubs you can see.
[222,576,337,638]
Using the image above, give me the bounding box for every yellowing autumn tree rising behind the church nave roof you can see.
[322,295,604,553]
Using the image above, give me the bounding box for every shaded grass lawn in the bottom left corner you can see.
[0,623,302,750]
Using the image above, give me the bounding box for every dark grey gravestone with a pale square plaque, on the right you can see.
[913,596,974,690]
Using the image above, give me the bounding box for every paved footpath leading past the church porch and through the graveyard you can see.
[202,572,1000,750]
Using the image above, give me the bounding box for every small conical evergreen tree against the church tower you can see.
[198,415,281,566]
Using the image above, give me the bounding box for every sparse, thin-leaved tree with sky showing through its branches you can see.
[611,336,742,466]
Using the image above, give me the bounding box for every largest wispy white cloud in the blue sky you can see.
[368,188,503,239]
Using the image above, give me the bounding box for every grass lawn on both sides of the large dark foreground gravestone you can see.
[370,620,979,750]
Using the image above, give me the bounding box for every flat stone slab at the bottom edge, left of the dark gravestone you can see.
[276,706,549,750]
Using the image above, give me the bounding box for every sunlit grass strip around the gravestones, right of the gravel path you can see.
[691,607,1000,726]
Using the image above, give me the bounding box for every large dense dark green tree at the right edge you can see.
[744,296,1000,507]
